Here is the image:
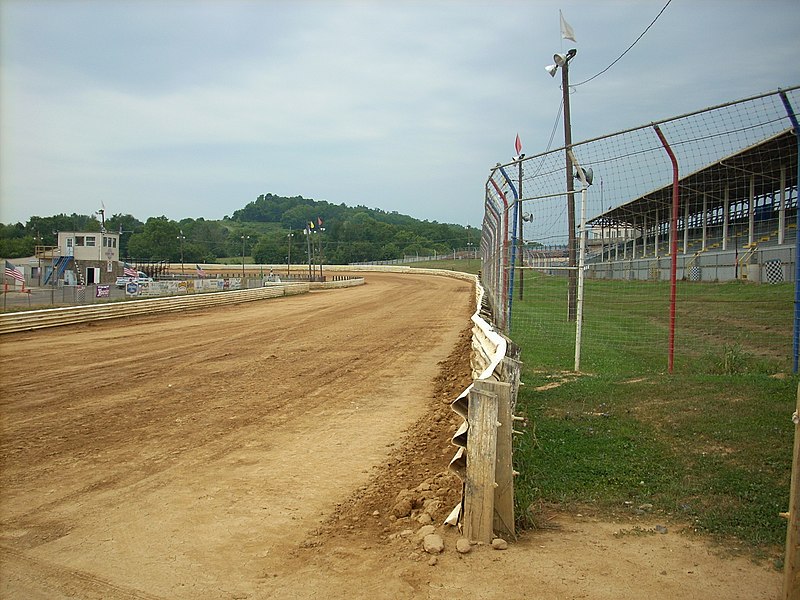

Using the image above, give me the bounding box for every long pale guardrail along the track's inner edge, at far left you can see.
[0,282,309,334]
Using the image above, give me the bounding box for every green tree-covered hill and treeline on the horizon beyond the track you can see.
[0,194,480,264]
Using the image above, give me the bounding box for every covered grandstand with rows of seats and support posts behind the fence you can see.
[584,129,798,281]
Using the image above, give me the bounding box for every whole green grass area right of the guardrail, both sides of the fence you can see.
[511,270,798,557]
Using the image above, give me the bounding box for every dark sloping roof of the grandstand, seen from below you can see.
[587,129,797,227]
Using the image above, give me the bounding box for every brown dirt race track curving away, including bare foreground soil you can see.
[0,274,781,600]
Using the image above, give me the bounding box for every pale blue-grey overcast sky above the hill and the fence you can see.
[0,0,800,226]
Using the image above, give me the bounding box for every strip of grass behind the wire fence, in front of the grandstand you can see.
[511,273,793,374]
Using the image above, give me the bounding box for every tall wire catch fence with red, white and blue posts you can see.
[481,87,800,370]
